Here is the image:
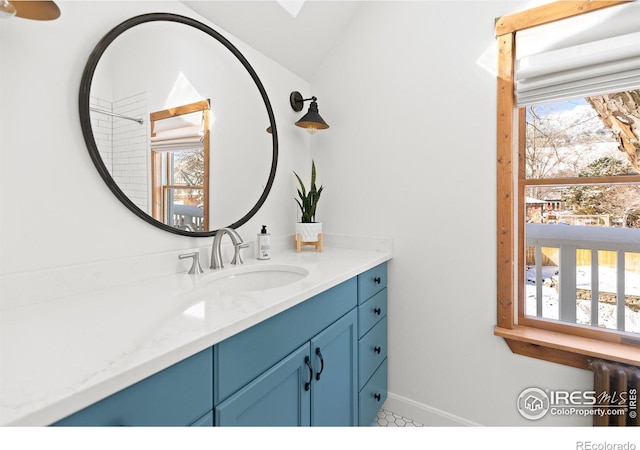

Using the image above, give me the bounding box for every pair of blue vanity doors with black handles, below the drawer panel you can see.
[216,309,358,426]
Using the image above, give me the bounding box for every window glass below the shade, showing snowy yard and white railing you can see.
[518,96,640,338]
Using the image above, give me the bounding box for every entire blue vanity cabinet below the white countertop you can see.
[48,264,387,426]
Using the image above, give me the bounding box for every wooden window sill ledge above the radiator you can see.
[493,326,640,370]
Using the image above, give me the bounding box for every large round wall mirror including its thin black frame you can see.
[79,13,278,236]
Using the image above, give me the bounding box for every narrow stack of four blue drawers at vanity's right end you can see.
[358,263,387,426]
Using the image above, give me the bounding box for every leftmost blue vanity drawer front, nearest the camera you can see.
[54,348,213,426]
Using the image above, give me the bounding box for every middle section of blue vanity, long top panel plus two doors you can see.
[214,279,358,426]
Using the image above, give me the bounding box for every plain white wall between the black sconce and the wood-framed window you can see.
[311,1,592,426]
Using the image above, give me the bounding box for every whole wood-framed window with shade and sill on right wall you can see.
[495,1,640,368]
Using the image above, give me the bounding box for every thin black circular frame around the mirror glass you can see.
[78,13,278,237]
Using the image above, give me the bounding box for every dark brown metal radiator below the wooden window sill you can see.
[590,359,640,427]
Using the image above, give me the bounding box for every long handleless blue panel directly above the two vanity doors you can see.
[214,278,357,405]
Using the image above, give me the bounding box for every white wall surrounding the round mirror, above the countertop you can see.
[0,0,309,275]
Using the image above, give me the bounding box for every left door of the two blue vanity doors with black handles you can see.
[215,343,313,427]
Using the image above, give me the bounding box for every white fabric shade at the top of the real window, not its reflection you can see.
[514,4,640,106]
